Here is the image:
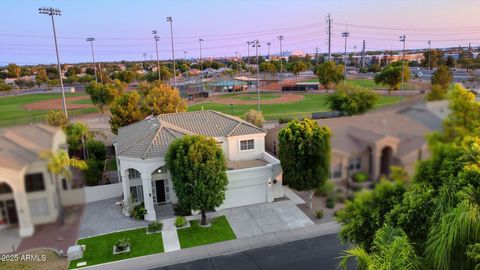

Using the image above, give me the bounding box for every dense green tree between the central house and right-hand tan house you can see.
[278,119,331,208]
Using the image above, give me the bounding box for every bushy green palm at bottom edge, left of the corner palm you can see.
[340,224,422,270]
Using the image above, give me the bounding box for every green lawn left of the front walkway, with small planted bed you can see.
[70,228,164,268]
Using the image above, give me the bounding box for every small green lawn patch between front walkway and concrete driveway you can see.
[177,216,236,248]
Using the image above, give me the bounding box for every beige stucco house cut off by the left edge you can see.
[0,125,83,237]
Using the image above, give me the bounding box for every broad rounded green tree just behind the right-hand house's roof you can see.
[325,84,379,115]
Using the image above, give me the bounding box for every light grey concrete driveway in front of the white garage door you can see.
[222,200,314,238]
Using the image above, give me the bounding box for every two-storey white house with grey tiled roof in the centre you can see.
[114,111,283,220]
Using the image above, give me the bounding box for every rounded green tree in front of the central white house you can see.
[165,135,228,225]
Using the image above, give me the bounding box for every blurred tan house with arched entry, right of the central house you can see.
[265,110,432,181]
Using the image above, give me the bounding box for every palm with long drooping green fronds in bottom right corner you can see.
[425,186,480,270]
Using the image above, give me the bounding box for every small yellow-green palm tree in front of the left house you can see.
[40,150,87,225]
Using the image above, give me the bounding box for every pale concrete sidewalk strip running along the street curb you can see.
[77,221,340,270]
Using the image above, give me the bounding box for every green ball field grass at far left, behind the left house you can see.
[0,93,98,126]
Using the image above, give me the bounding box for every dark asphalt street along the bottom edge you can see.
[152,234,356,270]
